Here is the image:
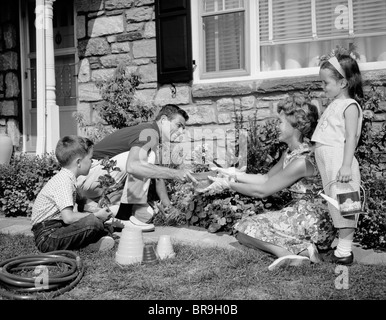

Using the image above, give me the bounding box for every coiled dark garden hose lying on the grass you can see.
[0,250,84,300]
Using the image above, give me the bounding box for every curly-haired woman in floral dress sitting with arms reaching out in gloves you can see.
[201,96,335,270]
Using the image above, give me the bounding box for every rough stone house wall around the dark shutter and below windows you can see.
[76,0,386,165]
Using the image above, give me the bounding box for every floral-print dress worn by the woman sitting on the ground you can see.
[234,143,336,254]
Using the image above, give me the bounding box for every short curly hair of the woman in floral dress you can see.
[277,94,319,140]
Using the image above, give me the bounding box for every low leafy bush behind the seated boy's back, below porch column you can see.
[0,154,60,216]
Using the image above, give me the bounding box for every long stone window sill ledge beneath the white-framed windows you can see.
[192,69,386,98]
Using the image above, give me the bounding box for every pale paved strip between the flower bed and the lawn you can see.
[0,216,386,266]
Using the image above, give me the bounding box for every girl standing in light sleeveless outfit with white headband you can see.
[311,52,363,265]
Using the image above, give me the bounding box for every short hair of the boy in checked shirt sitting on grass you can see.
[55,135,94,167]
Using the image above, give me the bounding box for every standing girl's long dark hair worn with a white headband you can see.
[320,47,363,103]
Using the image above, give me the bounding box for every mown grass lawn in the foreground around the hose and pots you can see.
[0,234,386,300]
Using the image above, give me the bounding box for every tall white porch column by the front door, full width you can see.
[35,0,60,154]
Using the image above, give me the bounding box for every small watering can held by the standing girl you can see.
[318,180,366,217]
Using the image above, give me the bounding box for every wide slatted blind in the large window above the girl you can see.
[259,0,386,45]
